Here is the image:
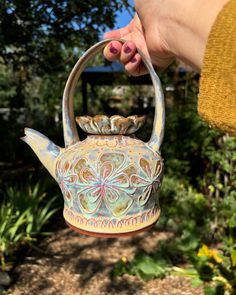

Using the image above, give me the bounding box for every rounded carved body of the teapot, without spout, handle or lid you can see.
[56,135,163,236]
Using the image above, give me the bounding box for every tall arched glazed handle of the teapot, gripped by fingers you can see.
[62,39,165,152]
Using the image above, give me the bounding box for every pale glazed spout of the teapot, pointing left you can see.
[21,128,62,179]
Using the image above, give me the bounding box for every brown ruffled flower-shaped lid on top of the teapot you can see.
[76,115,145,135]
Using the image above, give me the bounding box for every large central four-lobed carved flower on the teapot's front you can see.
[75,153,135,217]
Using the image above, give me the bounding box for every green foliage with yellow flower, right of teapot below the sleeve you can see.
[111,69,236,295]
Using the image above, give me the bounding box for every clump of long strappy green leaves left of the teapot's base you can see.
[0,182,58,269]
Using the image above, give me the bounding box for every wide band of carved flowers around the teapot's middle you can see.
[57,152,162,217]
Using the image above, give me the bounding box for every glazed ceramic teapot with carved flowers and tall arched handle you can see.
[22,39,165,237]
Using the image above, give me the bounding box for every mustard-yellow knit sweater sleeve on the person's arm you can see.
[198,0,236,135]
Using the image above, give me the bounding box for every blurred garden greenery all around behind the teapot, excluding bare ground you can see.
[0,0,236,295]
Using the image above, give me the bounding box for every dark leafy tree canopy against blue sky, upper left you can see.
[0,0,122,76]
